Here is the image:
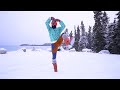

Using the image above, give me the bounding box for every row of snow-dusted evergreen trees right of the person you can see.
[69,11,120,54]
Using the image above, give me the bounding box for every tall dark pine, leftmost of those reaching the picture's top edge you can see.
[93,11,106,53]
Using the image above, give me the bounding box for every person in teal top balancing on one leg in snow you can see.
[45,17,67,72]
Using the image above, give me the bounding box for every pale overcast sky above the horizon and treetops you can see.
[0,11,118,45]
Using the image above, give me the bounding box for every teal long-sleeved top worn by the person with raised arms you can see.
[45,18,65,42]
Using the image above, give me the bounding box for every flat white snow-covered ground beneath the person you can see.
[0,49,120,79]
